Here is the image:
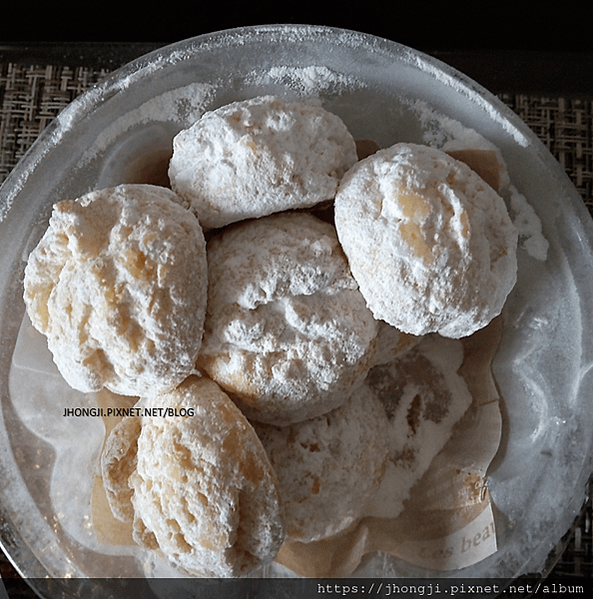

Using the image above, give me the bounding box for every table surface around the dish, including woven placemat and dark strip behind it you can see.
[0,42,593,598]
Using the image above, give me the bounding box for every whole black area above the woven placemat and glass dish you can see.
[0,0,593,97]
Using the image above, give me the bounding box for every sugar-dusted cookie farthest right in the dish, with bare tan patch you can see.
[335,143,517,338]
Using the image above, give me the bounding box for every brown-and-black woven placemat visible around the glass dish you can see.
[0,63,593,597]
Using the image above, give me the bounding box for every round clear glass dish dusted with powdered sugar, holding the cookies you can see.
[0,25,593,596]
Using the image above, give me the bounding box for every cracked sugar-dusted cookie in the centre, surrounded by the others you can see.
[197,212,377,425]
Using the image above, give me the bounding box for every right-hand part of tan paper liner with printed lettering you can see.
[277,317,502,578]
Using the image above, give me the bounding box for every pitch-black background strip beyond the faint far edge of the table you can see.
[0,0,592,52]
